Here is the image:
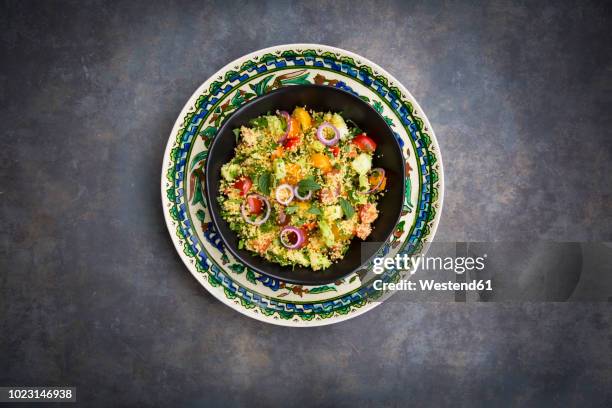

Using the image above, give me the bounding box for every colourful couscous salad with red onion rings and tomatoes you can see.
[217,106,387,271]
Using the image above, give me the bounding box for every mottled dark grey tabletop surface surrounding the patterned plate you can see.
[0,0,612,406]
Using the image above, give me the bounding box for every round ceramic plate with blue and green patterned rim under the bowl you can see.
[161,44,444,326]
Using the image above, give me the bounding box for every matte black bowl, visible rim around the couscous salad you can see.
[206,85,404,285]
